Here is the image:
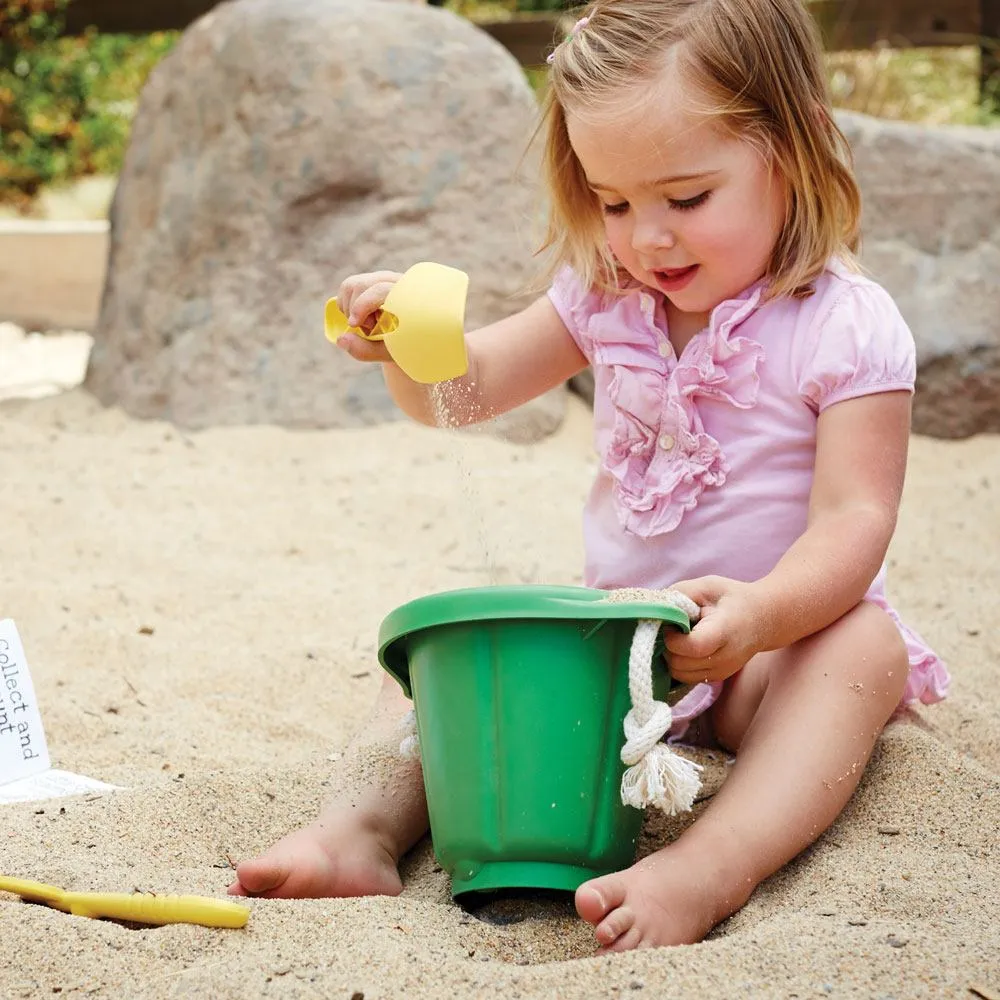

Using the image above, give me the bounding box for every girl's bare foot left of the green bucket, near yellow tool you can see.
[228,812,403,899]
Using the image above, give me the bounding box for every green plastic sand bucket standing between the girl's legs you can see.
[379,586,690,896]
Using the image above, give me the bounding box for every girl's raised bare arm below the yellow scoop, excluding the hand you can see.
[380,296,587,427]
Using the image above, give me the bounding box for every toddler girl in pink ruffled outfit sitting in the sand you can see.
[231,0,948,950]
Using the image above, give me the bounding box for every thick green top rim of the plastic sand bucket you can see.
[378,584,691,697]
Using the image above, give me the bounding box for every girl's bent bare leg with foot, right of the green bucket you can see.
[576,603,909,951]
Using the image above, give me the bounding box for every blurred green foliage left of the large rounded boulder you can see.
[0,0,175,209]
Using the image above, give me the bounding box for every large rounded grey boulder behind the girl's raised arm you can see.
[86,0,564,440]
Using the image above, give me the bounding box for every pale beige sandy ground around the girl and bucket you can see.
[0,372,1000,1000]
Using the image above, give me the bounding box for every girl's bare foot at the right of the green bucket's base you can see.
[576,842,756,952]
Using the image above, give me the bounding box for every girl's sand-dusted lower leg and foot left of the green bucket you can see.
[229,677,427,898]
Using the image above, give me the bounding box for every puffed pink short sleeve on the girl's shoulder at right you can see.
[797,280,917,413]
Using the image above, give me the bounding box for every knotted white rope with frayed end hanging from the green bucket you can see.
[621,602,701,816]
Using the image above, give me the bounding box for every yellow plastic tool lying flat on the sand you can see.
[0,875,250,927]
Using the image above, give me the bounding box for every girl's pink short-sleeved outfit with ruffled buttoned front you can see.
[549,264,949,736]
